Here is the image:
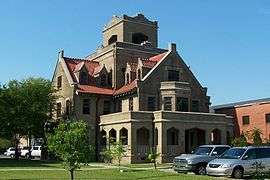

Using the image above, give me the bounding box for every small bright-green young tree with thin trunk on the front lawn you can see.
[48,121,93,180]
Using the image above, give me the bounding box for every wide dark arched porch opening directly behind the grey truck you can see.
[185,128,205,153]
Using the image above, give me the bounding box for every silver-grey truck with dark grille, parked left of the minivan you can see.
[173,145,230,175]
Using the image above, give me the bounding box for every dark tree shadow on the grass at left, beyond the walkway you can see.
[0,158,60,168]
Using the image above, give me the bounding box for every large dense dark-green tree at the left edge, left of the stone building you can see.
[0,78,55,158]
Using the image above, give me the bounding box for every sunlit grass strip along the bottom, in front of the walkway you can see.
[0,169,213,180]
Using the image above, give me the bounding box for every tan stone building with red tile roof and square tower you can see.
[53,14,233,163]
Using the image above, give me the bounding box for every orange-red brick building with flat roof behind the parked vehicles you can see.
[211,98,270,139]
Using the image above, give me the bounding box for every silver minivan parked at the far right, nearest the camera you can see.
[206,146,270,179]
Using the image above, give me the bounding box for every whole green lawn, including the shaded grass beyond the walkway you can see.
[0,159,210,180]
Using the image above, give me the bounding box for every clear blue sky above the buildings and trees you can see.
[0,0,270,105]
